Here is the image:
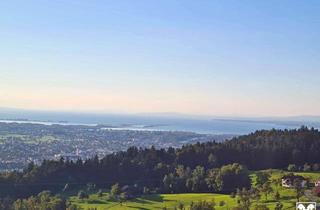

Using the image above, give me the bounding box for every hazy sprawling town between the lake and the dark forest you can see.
[0,122,230,171]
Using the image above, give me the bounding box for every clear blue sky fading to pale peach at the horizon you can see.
[0,0,320,116]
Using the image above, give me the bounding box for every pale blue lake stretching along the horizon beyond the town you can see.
[0,111,320,135]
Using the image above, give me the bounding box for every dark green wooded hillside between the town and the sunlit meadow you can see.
[0,127,320,197]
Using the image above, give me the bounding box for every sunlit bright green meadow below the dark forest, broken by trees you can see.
[69,170,320,210]
